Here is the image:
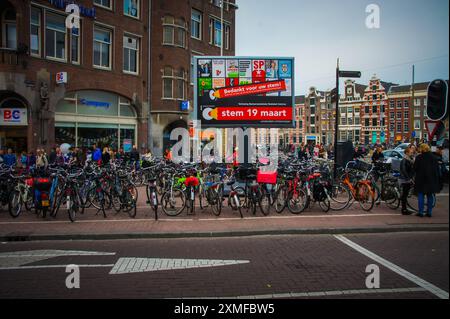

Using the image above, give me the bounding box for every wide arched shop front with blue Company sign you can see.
[55,91,138,150]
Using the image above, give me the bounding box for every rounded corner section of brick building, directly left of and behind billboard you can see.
[150,0,236,154]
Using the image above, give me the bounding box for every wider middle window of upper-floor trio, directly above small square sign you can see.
[45,14,67,61]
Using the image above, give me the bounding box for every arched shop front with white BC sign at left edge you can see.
[0,92,28,153]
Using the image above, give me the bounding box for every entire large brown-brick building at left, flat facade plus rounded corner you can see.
[0,0,235,154]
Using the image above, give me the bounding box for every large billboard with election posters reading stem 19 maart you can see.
[194,56,295,128]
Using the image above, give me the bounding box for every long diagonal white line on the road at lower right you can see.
[334,235,449,299]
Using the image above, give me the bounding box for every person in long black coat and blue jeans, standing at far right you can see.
[414,143,441,217]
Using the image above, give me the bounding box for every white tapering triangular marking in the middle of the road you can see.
[109,257,250,275]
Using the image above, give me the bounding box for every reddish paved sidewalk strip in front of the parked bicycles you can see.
[0,189,449,241]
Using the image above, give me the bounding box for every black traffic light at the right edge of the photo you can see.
[427,80,448,121]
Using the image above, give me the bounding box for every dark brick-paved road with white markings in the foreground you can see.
[0,232,449,299]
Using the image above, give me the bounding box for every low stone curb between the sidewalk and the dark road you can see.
[0,224,449,242]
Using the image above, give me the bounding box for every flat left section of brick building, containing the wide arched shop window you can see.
[0,0,149,151]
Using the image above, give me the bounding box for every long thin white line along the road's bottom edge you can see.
[178,287,427,299]
